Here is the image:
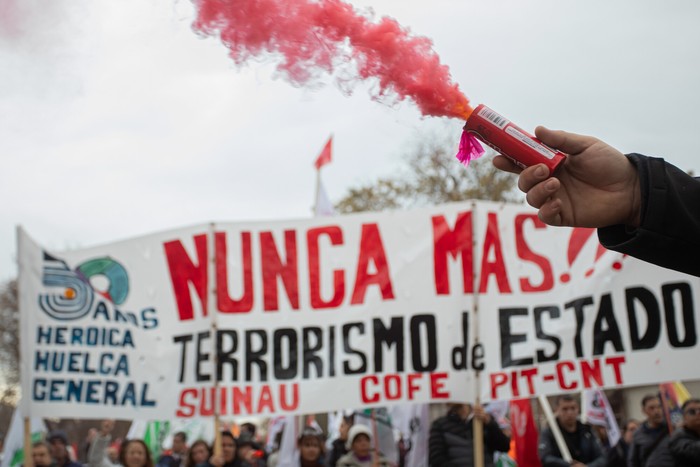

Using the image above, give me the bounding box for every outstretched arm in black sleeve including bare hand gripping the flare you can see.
[493,127,700,276]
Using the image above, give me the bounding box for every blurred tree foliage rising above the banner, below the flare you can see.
[336,131,522,213]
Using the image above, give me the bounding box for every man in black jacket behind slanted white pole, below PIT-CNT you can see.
[539,394,606,467]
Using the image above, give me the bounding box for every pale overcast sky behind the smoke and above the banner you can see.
[0,0,700,280]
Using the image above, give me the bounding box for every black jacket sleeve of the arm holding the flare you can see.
[598,154,700,276]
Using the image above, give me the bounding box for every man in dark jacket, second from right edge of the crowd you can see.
[627,394,674,467]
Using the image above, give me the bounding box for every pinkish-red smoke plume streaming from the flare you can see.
[194,0,472,119]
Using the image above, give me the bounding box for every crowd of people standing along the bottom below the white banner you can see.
[20,395,700,467]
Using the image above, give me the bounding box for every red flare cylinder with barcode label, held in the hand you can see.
[464,104,566,174]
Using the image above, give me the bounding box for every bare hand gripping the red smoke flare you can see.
[493,127,641,227]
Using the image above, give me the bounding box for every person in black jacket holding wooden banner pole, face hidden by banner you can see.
[428,404,510,467]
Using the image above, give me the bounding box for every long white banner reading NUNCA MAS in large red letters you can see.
[19,202,699,419]
